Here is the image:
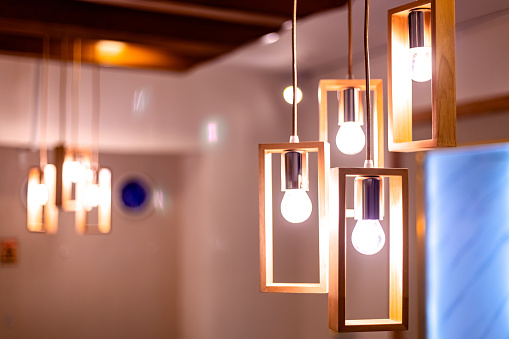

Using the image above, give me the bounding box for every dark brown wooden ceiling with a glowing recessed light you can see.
[0,0,347,71]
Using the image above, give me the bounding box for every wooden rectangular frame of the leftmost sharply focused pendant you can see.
[258,141,330,293]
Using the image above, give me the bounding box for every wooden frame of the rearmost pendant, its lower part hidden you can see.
[318,79,384,167]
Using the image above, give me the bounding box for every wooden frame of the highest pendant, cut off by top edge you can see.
[387,0,456,152]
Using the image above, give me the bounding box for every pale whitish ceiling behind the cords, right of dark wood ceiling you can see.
[221,0,509,72]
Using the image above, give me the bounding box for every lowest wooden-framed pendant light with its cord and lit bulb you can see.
[329,0,408,332]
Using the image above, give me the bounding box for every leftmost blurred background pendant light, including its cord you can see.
[27,36,58,233]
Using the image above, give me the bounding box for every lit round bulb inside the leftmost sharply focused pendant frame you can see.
[281,189,313,224]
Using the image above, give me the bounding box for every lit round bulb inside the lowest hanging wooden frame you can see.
[352,220,385,255]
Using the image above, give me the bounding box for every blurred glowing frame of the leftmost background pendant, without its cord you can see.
[27,164,58,234]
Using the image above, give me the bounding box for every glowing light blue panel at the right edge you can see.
[425,145,509,339]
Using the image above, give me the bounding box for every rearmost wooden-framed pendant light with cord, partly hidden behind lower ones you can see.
[318,0,384,167]
